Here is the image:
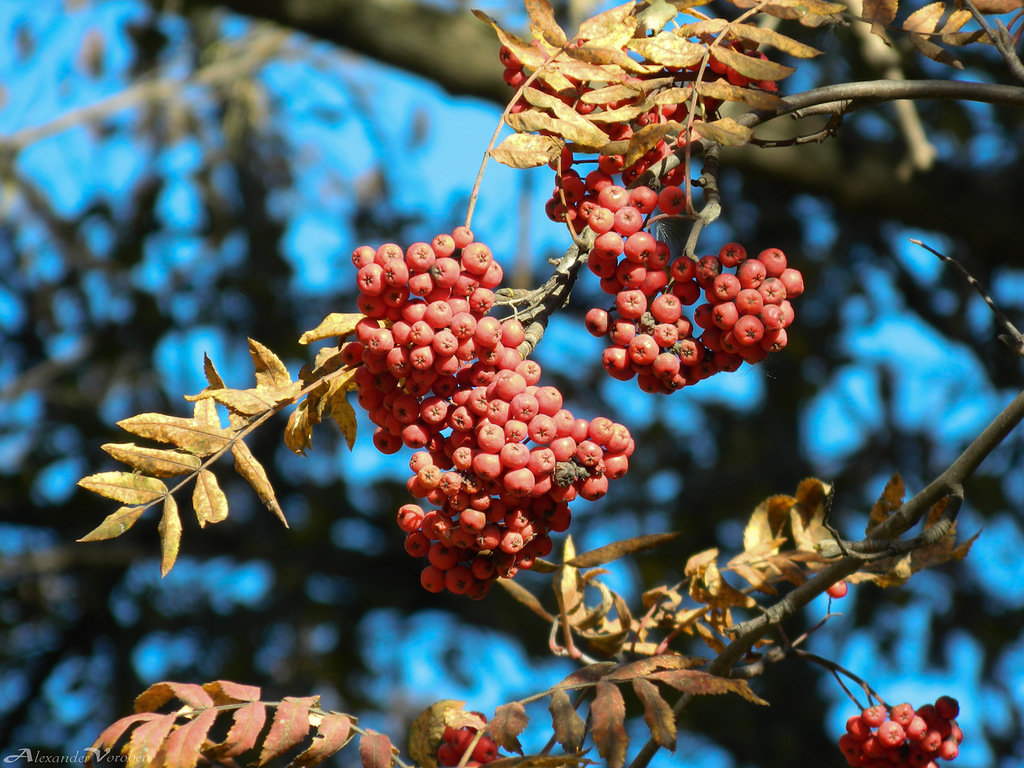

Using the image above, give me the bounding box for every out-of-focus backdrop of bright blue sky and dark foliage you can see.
[0,0,1024,768]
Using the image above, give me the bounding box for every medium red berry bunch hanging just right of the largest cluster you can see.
[586,239,804,394]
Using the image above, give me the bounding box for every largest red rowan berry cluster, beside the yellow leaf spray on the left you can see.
[342,227,634,598]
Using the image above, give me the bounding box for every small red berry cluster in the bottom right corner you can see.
[839,696,964,768]
